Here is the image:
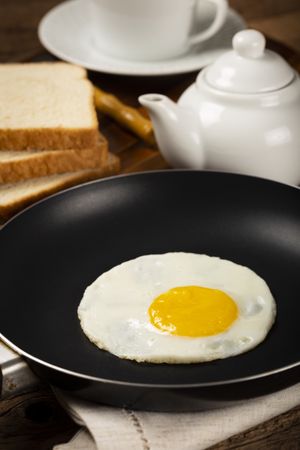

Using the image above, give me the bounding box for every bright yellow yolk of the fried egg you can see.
[148,286,238,337]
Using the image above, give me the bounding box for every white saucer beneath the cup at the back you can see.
[38,0,246,75]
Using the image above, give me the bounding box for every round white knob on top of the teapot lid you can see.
[232,30,266,59]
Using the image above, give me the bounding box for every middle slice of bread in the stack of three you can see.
[0,133,108,183]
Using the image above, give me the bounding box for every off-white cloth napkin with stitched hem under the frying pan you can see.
[54,383,300,450]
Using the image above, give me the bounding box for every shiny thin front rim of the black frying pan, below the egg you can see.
[0,333,300,389]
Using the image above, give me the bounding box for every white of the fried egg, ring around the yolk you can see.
[78,252,276,363]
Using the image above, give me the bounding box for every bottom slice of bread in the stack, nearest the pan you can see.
[0,153,120,222]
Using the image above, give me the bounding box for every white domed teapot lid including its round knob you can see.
[203,29,294,94]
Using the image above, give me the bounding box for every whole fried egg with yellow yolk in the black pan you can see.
[78,252,276,364]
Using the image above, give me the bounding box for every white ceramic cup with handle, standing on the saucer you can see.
[90,0,228,61]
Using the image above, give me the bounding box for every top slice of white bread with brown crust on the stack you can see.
[0,62,98,151]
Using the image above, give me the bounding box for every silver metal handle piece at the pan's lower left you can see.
[0,340,40,400]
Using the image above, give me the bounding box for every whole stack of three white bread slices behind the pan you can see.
[0,63,119,221]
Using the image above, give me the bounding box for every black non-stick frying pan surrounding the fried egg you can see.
[0,170,300,411]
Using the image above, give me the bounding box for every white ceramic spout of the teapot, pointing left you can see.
[139,94,205,169]
